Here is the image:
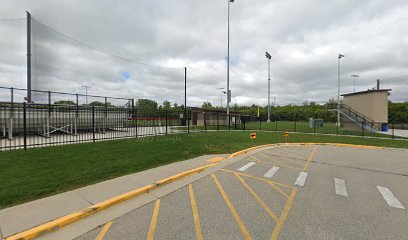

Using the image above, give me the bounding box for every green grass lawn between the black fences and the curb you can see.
[0,132,408,208]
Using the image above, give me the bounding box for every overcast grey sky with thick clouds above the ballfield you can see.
[0,0,408,106]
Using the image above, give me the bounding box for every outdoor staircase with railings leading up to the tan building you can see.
[333,104,381,132]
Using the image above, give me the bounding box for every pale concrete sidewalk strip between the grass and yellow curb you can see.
[0,154,228,238]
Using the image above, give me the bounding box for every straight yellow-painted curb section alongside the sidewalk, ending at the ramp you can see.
[5,163,216,240]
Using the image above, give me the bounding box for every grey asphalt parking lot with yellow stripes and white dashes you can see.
[77,145,408,240]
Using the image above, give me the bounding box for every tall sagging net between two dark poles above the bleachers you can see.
[32,18,184,105]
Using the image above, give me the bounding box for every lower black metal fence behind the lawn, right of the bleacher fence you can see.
[190,112,408,139]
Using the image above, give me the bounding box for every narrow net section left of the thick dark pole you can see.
[0,18,27,102]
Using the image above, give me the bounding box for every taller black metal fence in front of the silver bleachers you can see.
[0,103,188,150]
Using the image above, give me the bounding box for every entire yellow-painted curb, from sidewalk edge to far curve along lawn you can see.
[4,143,384,240]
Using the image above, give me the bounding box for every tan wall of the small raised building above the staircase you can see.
[343,91,388,123]
